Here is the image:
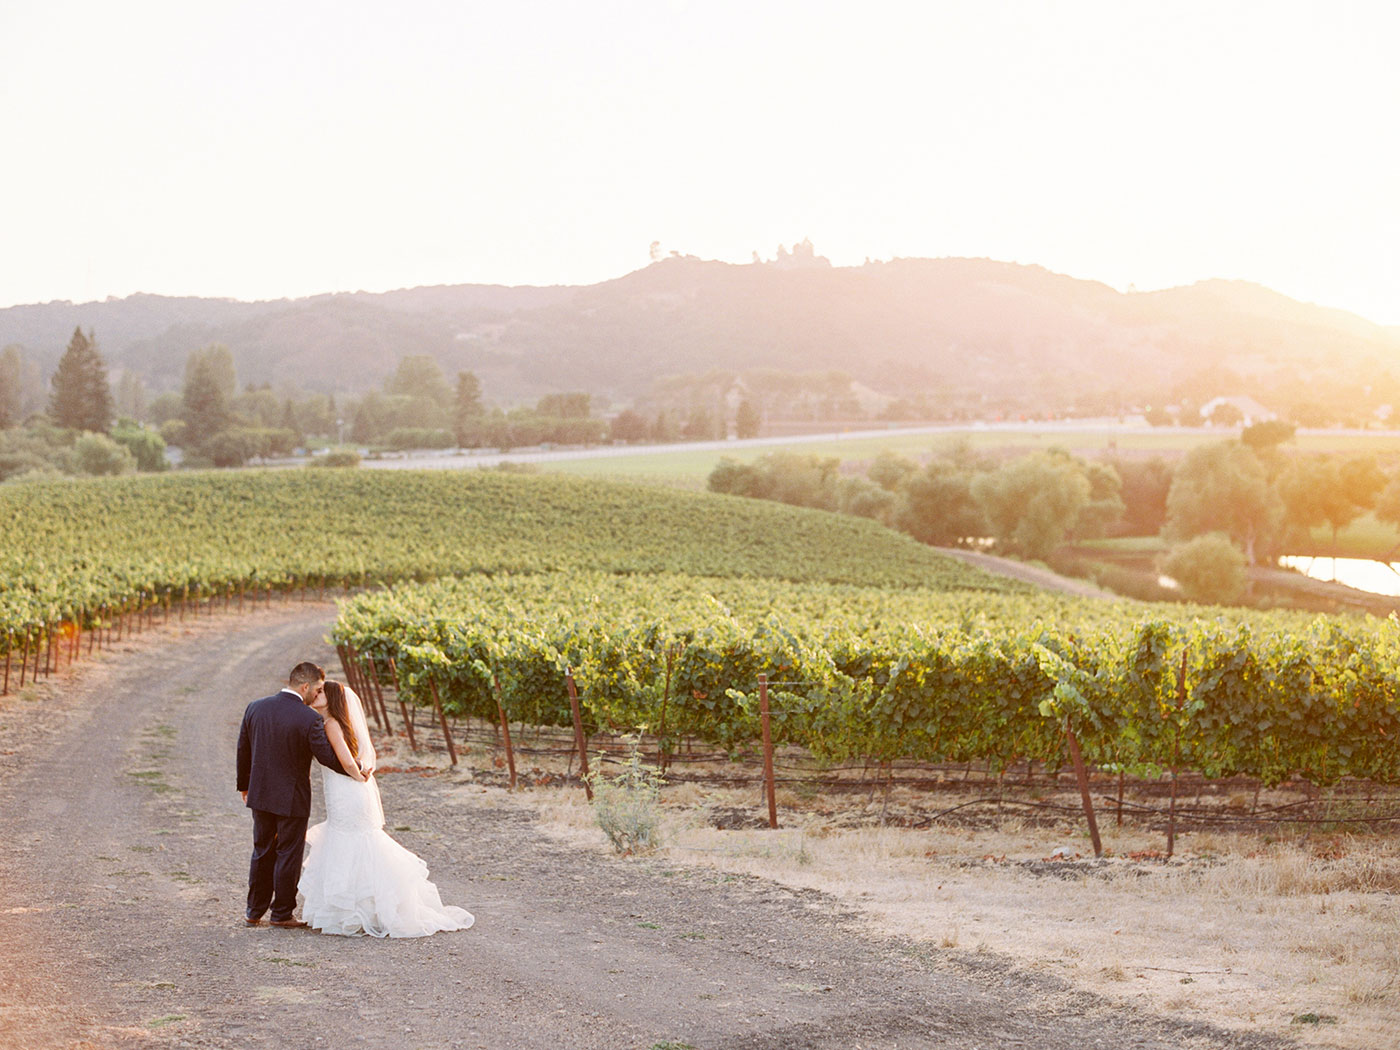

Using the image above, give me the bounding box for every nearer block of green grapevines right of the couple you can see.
[335,573,1400,784]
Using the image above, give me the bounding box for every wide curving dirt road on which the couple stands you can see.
[0,605,1277,1050]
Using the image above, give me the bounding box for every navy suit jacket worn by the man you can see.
[238,689,344,816]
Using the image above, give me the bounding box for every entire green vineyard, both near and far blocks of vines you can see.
[8,470,1400,806]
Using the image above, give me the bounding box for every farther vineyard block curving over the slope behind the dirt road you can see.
[0,470,1023,665]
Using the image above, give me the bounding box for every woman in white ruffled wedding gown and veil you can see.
[297,682,475,937]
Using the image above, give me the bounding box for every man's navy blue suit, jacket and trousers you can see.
[238,689,343,921]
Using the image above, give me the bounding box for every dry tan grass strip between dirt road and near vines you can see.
[525,767,1400,1050]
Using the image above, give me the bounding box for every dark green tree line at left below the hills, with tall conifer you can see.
[0,329,778,480]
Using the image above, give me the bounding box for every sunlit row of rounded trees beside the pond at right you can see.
[708,423,1400,602]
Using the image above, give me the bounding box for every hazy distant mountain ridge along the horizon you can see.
[0,256,1400,403]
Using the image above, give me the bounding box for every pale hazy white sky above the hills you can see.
[0,0,1400,323]
